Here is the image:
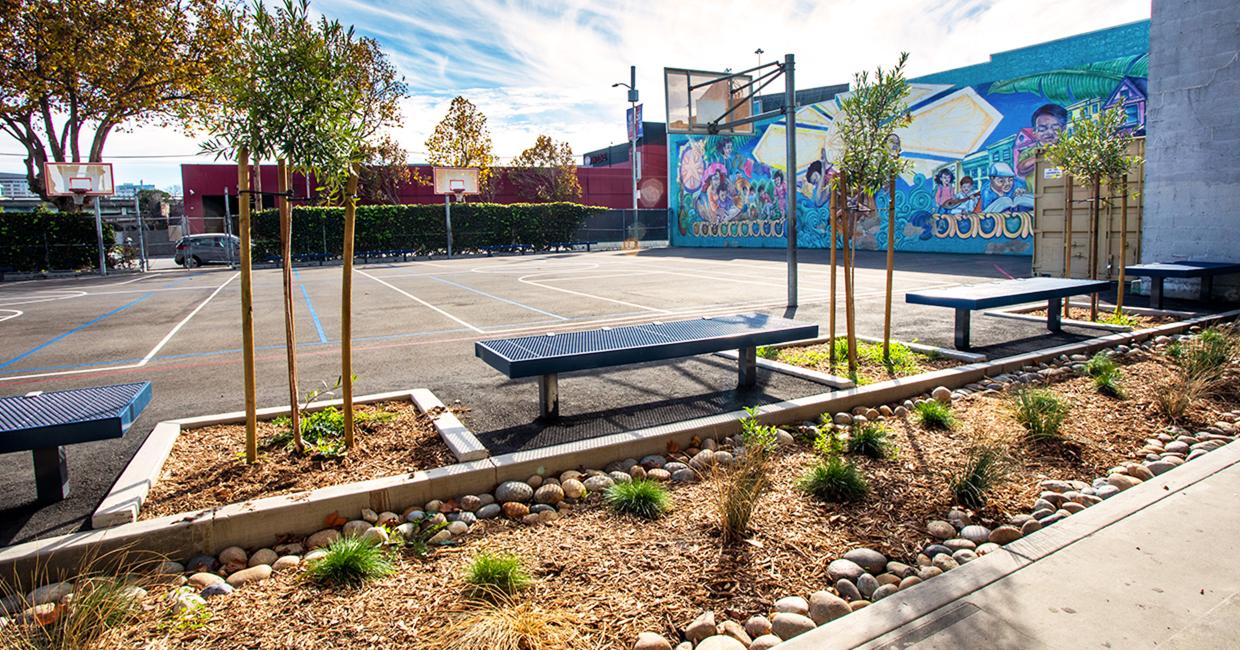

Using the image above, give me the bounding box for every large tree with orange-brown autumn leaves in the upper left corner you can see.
[0,0,236,200]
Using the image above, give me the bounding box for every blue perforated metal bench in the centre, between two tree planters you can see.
[474,314,818,419]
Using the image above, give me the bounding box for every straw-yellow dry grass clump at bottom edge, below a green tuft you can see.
[427,597,582,650]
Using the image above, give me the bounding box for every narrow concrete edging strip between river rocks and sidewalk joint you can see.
[777,443,1240,650]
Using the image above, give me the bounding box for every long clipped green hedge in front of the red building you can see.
[253,203,606,259]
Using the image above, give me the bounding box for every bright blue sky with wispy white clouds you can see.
[0,0,1149,187]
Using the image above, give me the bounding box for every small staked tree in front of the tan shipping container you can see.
[1047,107,1141,320]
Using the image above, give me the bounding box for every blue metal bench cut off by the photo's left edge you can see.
[0,382,151,504]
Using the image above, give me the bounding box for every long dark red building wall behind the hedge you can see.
[181,145,667,233]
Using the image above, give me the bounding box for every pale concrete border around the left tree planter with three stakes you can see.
[91,390,466,528]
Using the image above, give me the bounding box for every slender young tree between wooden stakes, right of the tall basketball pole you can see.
[832,52,913,375]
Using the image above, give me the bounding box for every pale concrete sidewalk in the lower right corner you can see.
[779,443,1240,650]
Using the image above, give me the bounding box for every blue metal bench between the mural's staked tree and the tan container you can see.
[904,278,1111,350]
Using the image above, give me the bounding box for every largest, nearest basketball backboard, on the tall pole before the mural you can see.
[663,68,754,134]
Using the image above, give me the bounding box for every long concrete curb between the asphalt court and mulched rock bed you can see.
[12,310,1240,583]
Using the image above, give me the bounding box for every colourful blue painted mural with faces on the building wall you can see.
[668,55,1147,254]
